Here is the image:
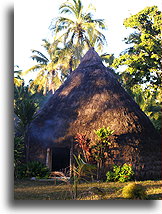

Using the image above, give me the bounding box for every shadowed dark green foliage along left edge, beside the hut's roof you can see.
[14,84,42,168]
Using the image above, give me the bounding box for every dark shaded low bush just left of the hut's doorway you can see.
[17,161,50,179]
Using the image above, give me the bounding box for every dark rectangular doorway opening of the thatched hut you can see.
[52,148,70,171]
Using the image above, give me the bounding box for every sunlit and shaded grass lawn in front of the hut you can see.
[14,180,162,200]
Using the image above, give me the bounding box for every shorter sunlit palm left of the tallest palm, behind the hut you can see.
[23,40,65,94]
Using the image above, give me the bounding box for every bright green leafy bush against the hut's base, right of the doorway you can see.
[106,163,134,182]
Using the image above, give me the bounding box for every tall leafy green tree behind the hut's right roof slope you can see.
[113,6,162,134]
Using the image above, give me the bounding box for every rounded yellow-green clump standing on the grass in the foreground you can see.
[122,183,147,199]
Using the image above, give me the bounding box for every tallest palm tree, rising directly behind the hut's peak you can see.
[51,0,107,68]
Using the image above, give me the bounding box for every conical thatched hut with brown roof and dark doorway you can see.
[28,48,162,179]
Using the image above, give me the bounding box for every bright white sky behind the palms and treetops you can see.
[14,0,162,83]
